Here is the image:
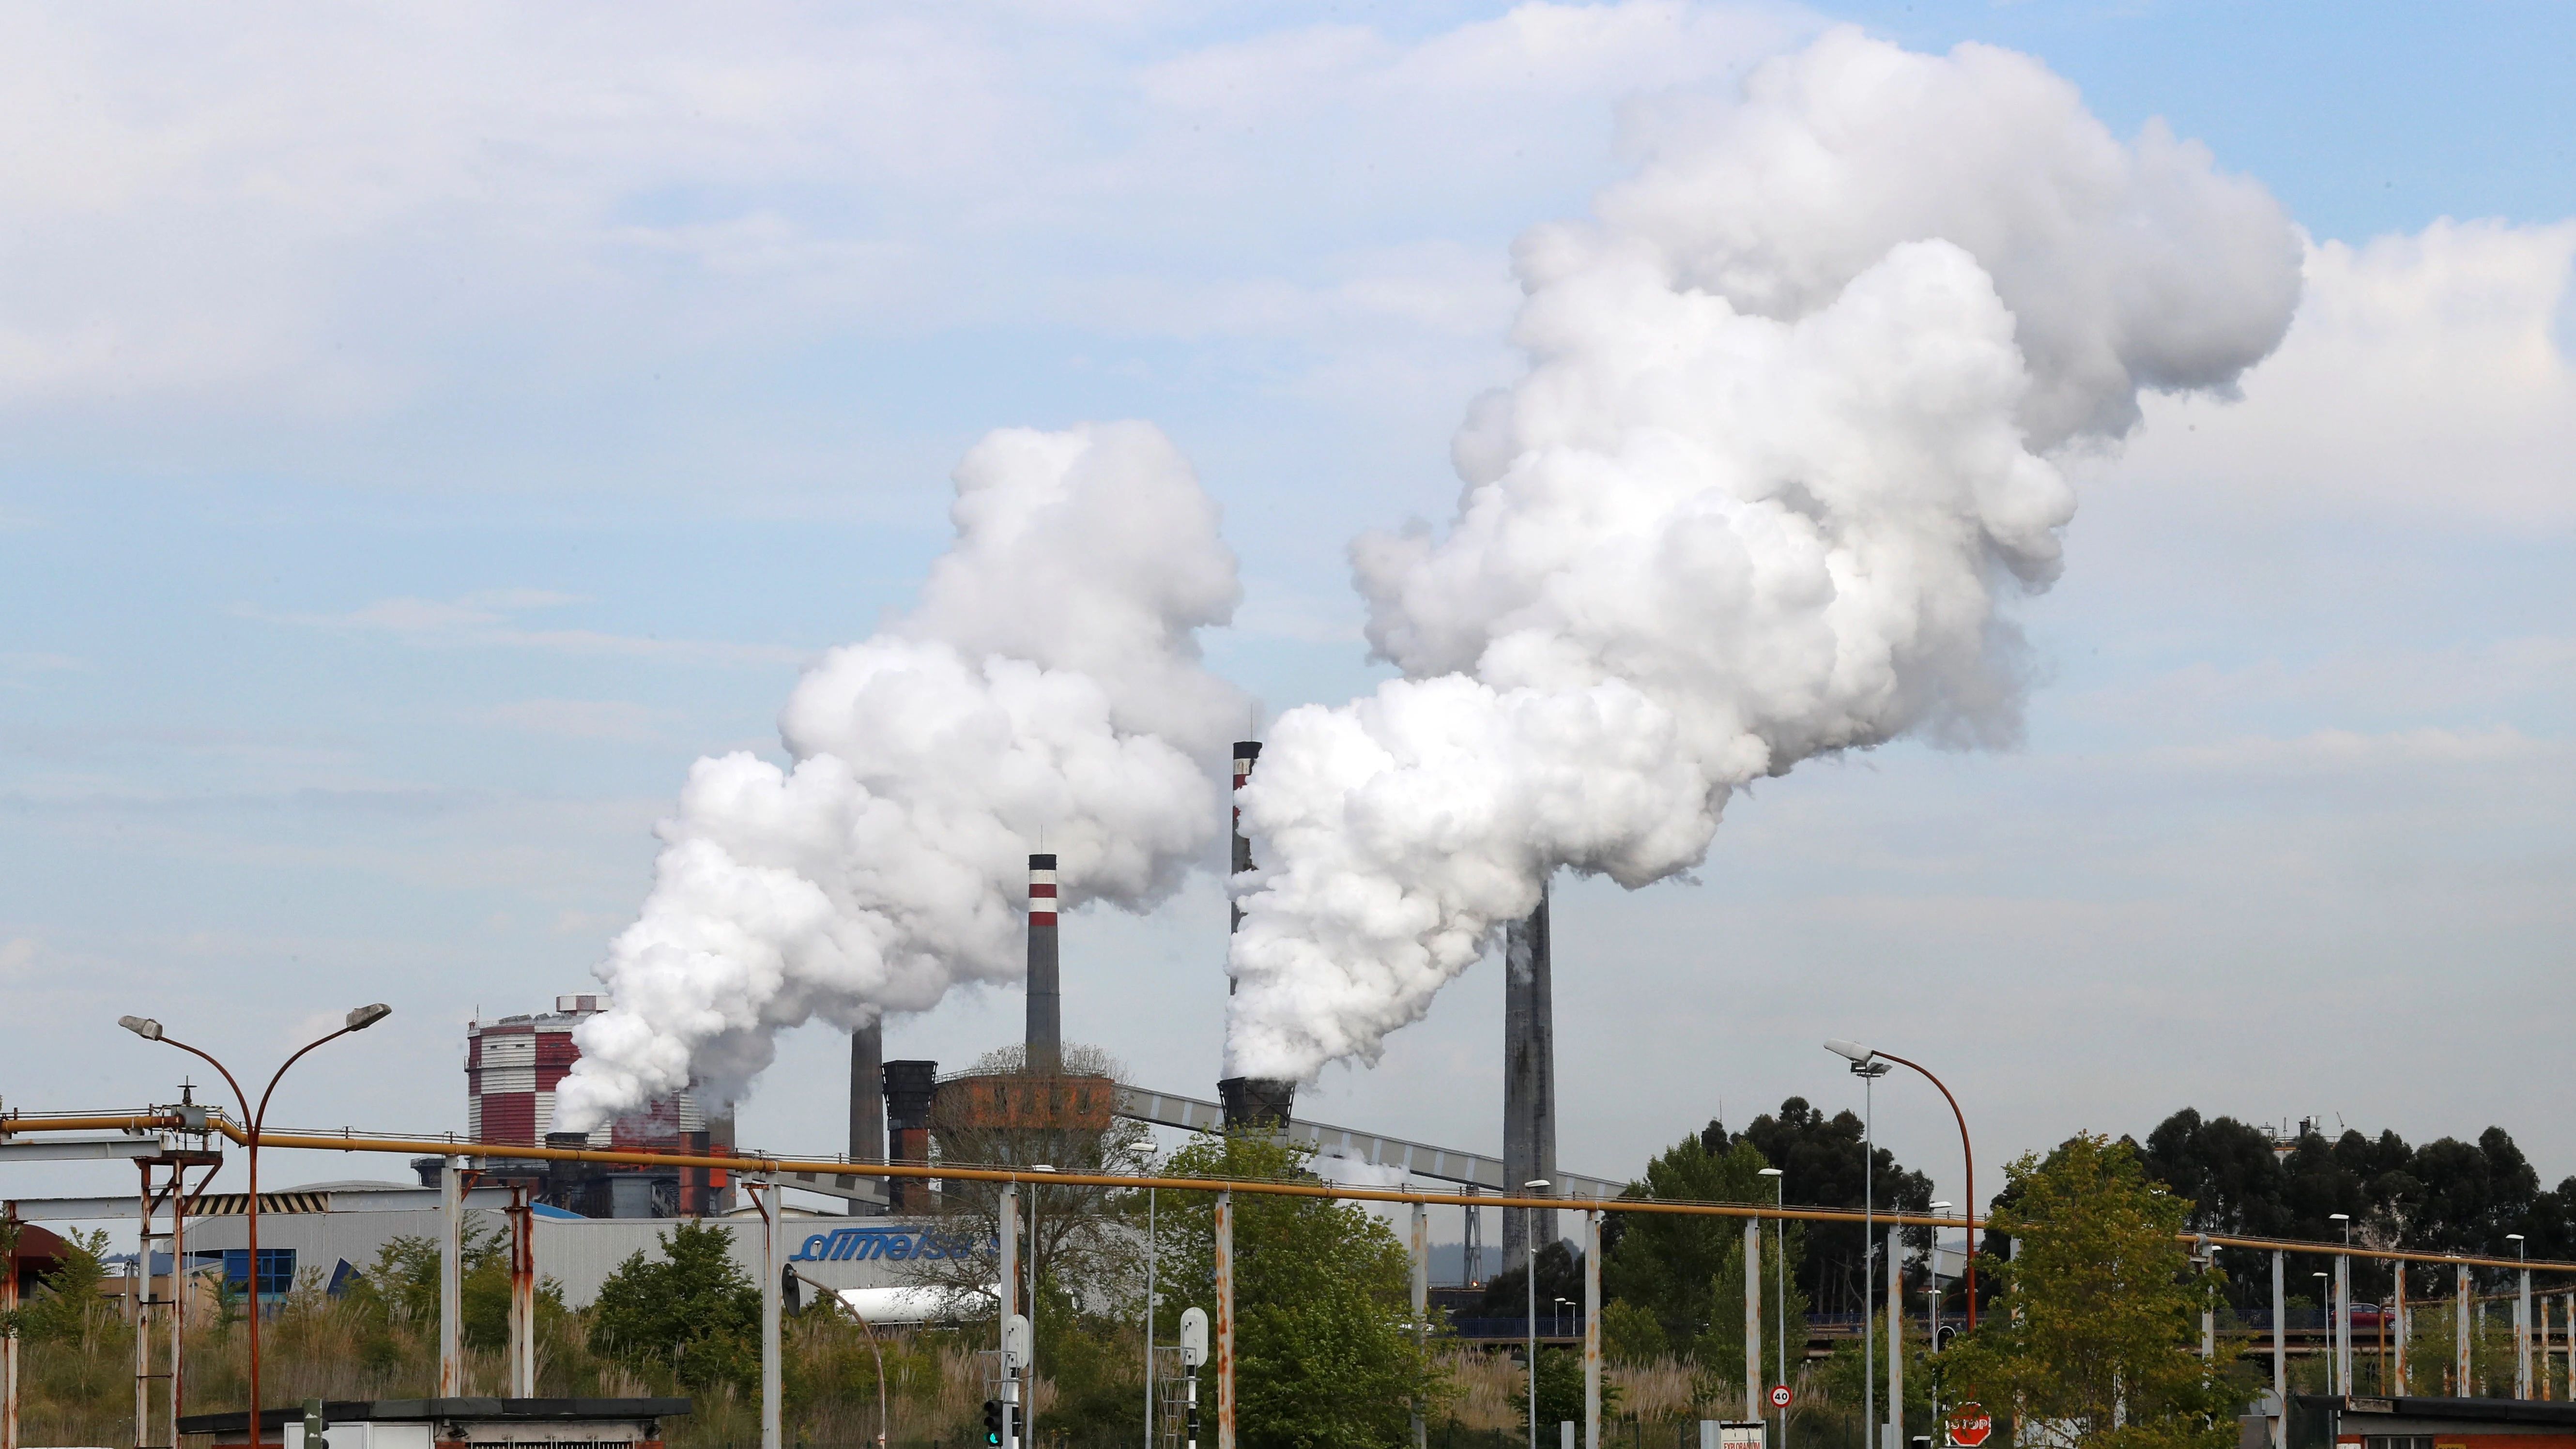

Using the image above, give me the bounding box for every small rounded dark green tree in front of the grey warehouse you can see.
[590,1222,760,1392]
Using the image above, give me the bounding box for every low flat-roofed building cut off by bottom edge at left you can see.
[178,1398,688,1449]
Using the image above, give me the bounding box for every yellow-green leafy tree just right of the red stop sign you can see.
[1942,1135,2249,1449]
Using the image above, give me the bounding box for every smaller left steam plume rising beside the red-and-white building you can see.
[556,422,1247,1130]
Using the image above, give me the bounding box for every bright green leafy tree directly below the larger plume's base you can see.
[1154,1130,1448,1449]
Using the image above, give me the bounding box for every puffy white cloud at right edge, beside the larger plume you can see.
[2120,221,2576,528]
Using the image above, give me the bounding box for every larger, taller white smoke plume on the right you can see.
[1226,31,2300,1078]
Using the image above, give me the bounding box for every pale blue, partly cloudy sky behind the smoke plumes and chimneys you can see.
[0,0,2576,1235]
